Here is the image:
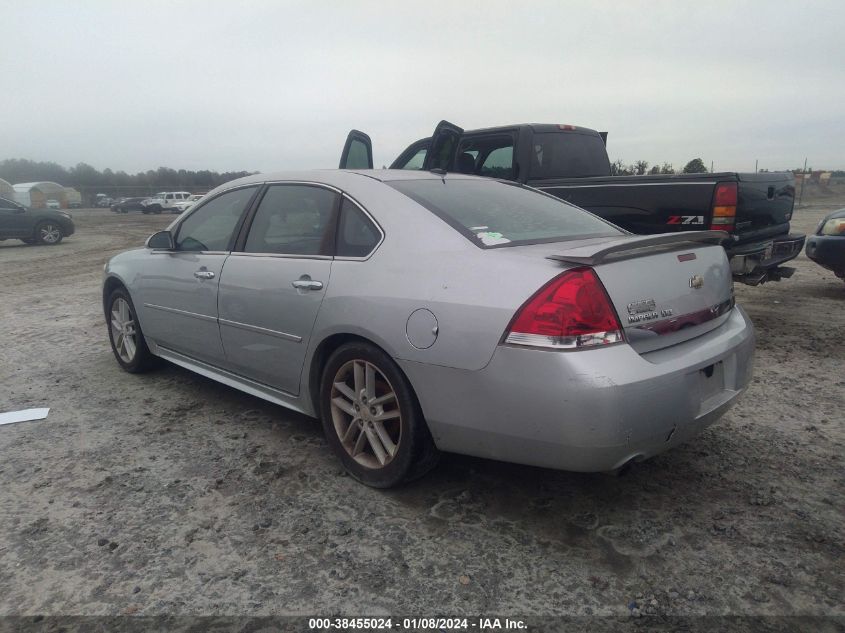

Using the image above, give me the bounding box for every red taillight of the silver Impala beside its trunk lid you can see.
[505,268,625,349]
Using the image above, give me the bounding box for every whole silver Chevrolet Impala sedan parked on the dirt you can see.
[103,170,754,487]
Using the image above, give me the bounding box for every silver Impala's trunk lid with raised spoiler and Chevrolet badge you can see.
[548,231,733,353]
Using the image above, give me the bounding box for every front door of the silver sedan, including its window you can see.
[133,185,259,366]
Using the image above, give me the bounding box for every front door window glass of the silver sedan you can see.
[176,186,258,251]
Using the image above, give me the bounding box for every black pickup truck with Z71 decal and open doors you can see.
[340,121,805,286]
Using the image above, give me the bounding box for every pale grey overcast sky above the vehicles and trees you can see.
[0,0,845,173]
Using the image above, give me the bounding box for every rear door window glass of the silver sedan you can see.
[244,185,337,255]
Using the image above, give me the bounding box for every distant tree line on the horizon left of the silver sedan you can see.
[0,158,254,195]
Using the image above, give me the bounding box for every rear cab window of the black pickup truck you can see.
[530,132,610,180]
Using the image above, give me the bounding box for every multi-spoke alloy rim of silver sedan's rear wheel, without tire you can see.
[331,360,402,468]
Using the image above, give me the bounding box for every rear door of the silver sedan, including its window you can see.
[219,183,339,395]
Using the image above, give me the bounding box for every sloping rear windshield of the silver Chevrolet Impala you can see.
[385,179,624,248]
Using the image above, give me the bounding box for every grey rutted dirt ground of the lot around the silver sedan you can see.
[0,199,845,621]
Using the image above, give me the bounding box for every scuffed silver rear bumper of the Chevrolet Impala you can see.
[400,307,754,472]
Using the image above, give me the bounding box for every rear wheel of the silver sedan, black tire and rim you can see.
[320,342,439,488]
